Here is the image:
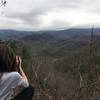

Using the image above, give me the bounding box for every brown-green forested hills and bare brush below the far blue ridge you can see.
[1,28,100,100]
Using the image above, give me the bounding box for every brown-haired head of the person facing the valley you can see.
[0,44,17,73]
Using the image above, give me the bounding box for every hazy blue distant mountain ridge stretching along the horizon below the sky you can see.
[0,28,100,40]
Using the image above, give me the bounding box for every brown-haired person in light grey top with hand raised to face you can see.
[0,44,34,100]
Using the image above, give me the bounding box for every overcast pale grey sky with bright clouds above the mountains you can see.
[0,0,100,31]
